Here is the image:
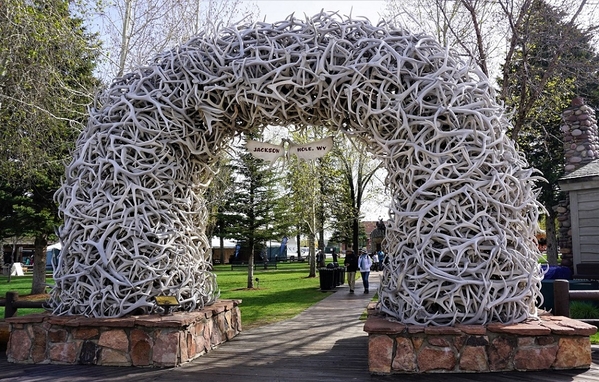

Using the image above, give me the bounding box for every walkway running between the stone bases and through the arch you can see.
[0,273,599,382]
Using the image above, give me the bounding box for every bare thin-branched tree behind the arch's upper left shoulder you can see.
[86,0,256,80]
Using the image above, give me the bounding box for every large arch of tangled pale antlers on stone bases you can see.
[52,13,541,325]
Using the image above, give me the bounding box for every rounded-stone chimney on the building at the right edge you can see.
[556,97,599,267]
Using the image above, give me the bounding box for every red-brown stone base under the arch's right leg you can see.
[364,304,597,374]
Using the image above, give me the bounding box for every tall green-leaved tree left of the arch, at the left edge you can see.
[0,0,97,293]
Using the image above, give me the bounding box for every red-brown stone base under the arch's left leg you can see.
[6,300,241,367]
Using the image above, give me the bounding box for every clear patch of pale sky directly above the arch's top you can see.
[244,0,385,24]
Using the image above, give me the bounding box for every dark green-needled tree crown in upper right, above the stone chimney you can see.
[500,0,597,141]
